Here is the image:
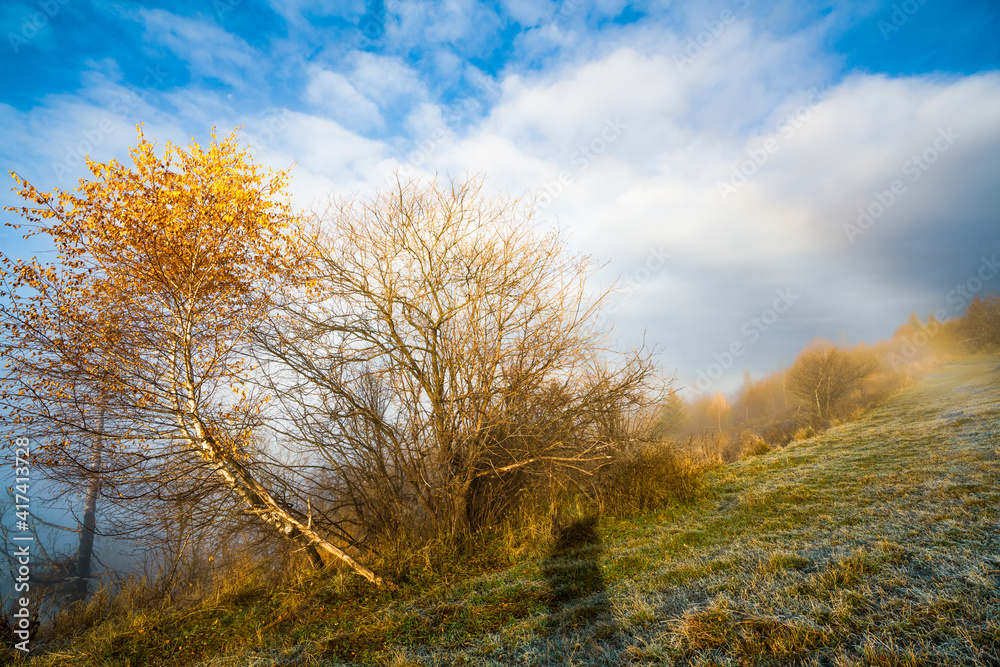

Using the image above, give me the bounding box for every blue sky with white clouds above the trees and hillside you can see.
[0,0,1000,392]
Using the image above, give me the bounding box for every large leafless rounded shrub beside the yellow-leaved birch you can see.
[261,180,666,550]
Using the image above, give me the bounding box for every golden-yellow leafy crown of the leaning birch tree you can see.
[0,126,304,468]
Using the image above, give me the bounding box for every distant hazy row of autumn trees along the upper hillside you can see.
[658,295,1000,462]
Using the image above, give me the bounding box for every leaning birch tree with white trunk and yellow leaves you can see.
[0,128,384,585]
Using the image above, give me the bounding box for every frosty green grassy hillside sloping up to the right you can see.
[21,356,1000,666]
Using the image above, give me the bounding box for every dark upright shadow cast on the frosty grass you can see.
[542,517,614,635]
